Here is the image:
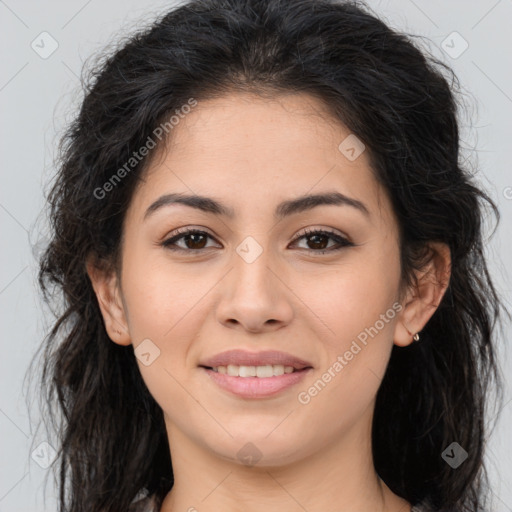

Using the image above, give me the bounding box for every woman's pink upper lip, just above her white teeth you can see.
[199,349,311,370]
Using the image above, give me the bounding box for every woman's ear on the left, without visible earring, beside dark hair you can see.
[86,257,131,345]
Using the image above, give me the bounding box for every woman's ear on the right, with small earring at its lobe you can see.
[393,242,451,347]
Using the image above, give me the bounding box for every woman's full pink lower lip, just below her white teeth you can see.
[203,367,312,398]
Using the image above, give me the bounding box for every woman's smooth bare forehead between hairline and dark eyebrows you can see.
[128,93,392,226]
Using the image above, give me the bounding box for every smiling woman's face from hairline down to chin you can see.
[94,94,415,465]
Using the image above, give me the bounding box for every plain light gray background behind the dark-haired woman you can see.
[0,0,512,512]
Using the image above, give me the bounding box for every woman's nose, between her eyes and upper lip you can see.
[217,245,293,333]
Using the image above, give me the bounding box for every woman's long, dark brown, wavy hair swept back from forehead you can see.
[32,0,508,512]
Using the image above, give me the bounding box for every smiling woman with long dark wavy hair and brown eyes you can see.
[35,0,501,512]
